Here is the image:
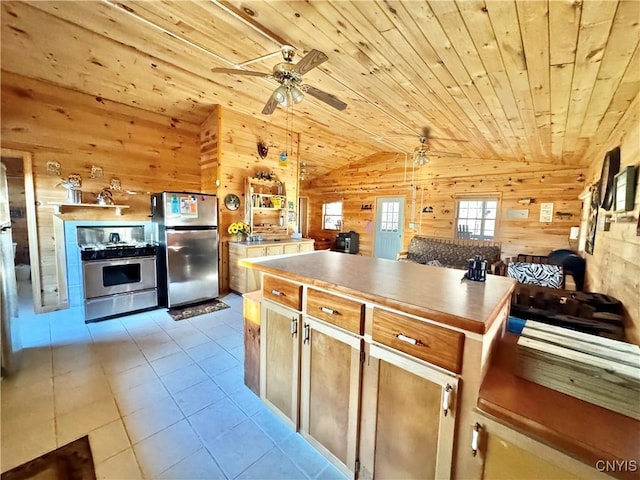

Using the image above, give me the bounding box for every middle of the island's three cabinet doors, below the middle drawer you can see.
[300,317,363,478]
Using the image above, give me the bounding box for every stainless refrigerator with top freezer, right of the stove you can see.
[151,192,219,308]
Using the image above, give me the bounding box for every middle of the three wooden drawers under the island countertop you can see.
[307,288,364,335]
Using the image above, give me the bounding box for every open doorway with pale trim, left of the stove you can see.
[2,148,42,313]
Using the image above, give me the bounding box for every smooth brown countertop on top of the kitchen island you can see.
[240,250,515,334]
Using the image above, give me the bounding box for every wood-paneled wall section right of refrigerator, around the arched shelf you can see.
[208,105,300,291]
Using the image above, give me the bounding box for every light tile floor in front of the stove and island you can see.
[0,283,344,479]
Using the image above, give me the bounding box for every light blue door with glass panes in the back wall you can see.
[373,197,404,260]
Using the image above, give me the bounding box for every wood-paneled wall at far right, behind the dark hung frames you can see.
[584,92,640,345]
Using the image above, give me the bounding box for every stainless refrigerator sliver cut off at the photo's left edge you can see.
[0,164,22,376]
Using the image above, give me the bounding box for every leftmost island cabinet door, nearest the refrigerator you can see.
[260,300,301,430]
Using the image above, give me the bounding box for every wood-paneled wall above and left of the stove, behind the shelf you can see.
[2,71,201,308]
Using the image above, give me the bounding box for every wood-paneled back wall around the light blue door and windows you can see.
[301,154,584,258]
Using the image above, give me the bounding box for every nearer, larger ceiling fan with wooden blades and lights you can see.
[211,45,347,115]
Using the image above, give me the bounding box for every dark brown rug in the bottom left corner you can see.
[0,435,96,480]
